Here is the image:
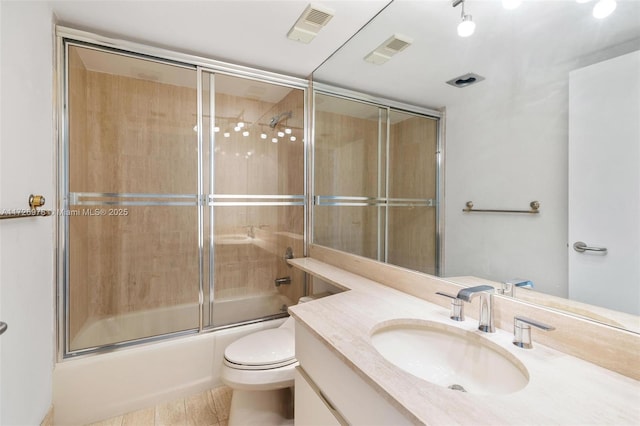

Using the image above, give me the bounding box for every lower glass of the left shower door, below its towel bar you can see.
[68,206,199,351]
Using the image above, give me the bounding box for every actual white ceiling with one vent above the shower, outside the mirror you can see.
[51,0,389,77]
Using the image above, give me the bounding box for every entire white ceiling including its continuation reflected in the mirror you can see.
[51,0,640,108]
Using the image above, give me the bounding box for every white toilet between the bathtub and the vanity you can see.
[222,298,308,426]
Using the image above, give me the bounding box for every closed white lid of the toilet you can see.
[224,328,295,366]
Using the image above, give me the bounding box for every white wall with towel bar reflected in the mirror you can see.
[444,56,568,297]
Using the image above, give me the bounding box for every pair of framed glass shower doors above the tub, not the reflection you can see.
[61,41,305,356]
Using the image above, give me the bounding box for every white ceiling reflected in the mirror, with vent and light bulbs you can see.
[314,0,640,108]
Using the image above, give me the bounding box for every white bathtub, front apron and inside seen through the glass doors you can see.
[53,294,290,425]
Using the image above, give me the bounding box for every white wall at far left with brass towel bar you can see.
[0,0,55,425]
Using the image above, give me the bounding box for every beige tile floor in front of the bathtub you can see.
[90,386,231,426]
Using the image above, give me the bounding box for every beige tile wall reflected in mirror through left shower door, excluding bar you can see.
[314,101,384,259]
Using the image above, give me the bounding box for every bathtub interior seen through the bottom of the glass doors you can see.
[70,293,291,350]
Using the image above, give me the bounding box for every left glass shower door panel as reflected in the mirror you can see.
[313,93,386,260]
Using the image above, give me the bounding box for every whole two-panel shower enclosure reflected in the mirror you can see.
[313,92,439,275]
